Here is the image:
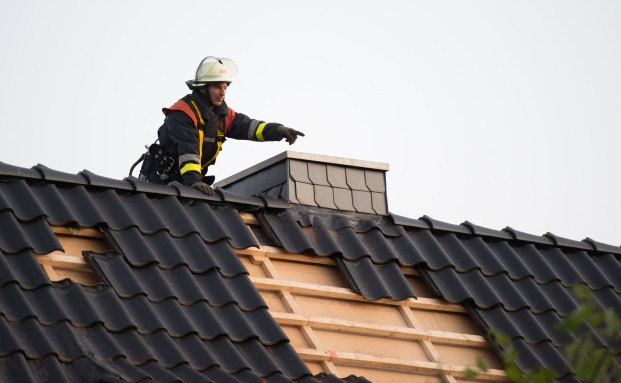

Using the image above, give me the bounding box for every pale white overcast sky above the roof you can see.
[0,0,621,245]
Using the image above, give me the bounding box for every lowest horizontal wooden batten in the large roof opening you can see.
[295,347,508,382]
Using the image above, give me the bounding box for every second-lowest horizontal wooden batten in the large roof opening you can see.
[272,312,487,347]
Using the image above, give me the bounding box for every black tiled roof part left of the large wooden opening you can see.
[0,163,366,383]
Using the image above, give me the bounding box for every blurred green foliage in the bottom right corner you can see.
[466,286,621,383]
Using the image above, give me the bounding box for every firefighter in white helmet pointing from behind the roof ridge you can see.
[140,56,304,195]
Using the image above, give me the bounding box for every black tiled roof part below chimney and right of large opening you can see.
[259,206,621,381]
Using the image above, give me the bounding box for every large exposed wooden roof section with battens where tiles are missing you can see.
[236,213,508,383]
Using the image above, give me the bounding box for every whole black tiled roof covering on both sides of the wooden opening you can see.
[0,154,621,382]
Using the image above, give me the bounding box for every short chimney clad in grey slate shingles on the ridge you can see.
[215,151,388,215]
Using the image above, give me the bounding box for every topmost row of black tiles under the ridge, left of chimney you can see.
[0,180,258,248]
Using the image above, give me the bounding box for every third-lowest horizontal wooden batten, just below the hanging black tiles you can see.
[250,277,468,313]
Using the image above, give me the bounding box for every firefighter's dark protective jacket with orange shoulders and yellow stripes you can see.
[158,91,282,186]
